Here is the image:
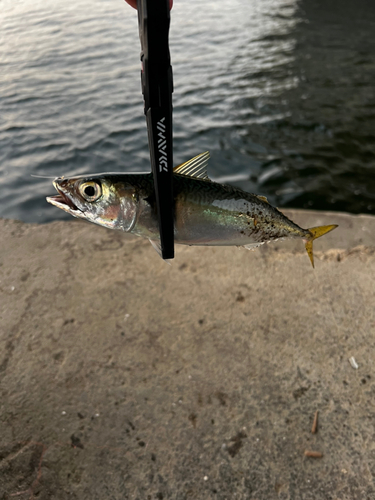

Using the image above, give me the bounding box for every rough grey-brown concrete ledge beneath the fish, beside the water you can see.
[0,211,375,500]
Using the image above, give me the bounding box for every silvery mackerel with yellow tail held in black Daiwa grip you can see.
[47,151,337,267]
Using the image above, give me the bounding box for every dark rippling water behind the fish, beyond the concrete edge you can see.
[0,0,375,222]
